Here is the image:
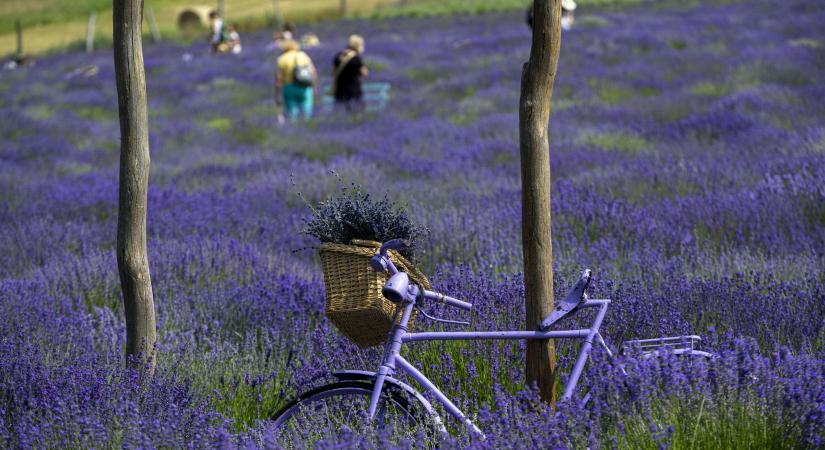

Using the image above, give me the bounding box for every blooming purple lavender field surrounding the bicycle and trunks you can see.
[0,0,825,449]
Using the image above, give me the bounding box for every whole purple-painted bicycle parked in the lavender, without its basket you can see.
[272,239,711,439]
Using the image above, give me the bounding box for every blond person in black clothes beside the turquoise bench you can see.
[332,34,369,111]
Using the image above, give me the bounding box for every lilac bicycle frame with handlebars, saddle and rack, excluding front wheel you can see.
[276,243,700,439]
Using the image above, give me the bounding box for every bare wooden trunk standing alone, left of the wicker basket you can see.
[113,0,157,371]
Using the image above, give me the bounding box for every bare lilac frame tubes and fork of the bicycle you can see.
[369,292,612,436]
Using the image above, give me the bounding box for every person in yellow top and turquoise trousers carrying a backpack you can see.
[275,39,318,122]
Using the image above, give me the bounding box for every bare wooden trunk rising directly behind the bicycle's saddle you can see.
[519,0,561,404]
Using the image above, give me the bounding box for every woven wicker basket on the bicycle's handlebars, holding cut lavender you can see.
[319,240,430,348]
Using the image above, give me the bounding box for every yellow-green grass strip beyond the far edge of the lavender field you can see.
[0,0,652,55]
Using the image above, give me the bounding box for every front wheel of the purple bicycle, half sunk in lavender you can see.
[271,381,432,448]
